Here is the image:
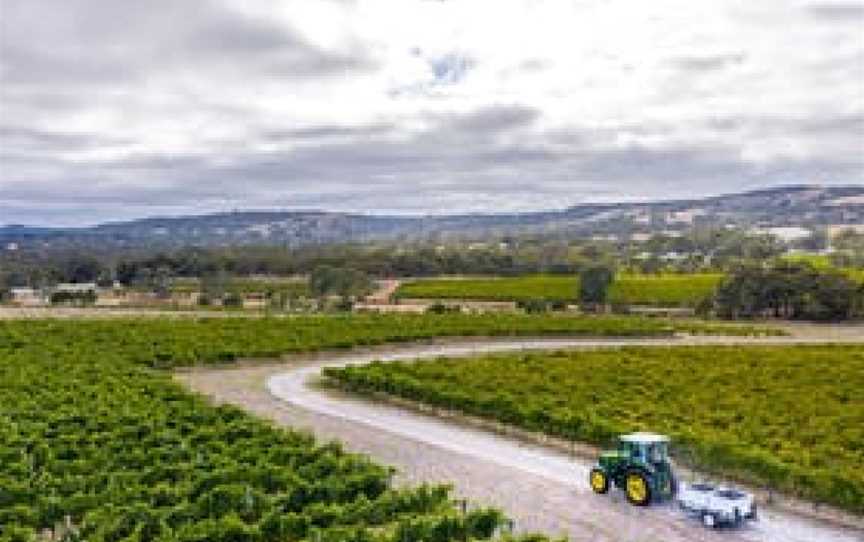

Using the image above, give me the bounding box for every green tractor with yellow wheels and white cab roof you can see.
[589,433,678,506]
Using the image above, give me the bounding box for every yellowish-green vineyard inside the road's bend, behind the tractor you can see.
[326,345,864,514]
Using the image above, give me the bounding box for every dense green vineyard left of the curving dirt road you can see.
[0,315,759,542]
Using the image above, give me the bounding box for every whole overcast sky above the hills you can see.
[0,0,864,226]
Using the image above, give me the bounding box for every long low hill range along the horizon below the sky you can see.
[0,185,864,249]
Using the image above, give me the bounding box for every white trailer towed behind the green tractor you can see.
[676,482,758,528]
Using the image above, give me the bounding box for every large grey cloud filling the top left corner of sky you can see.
[0,0,373,91]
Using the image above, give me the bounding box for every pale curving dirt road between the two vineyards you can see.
[178,328,864,542]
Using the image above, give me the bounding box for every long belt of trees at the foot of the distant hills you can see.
[8,229,864,286]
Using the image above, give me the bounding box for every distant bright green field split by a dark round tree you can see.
[397,274,723,307]
